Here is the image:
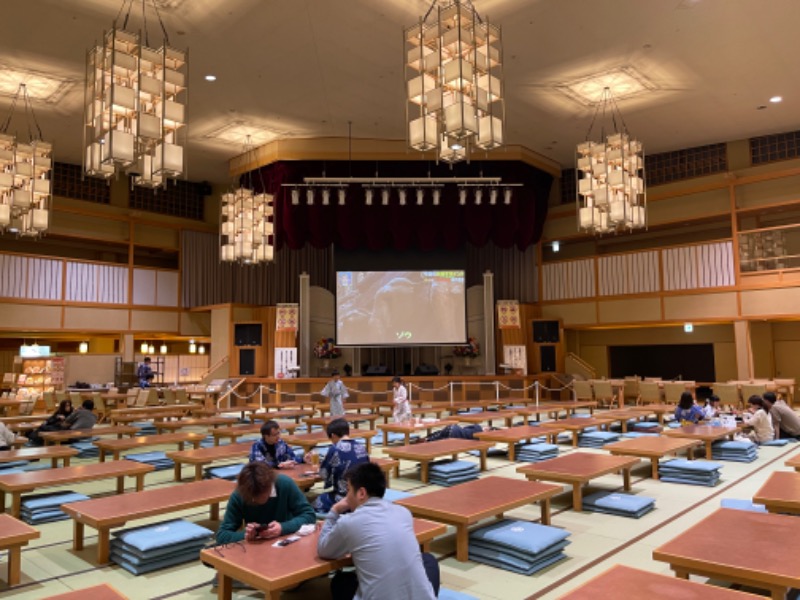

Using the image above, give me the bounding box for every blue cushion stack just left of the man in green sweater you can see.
[111,519,214,575]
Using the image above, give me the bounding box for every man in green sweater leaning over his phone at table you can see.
[217,462,316,544]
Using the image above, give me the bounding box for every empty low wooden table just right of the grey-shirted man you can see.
[395,477,561,562]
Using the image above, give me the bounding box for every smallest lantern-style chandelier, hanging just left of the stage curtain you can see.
[219,136,275,265]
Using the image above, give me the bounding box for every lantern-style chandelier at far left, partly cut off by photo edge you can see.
[0,83,53,237]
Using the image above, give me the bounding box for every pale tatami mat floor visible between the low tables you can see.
[0,418,800,600]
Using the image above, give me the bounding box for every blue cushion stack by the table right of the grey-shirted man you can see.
[469,520,570,575]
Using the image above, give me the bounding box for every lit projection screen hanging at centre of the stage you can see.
[336,270,467,346]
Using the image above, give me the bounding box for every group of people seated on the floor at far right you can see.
[675,392,800,444]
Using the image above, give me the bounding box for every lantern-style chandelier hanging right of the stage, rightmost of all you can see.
[575,88,647,235]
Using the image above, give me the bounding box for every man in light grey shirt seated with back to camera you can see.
[317,463,439,600]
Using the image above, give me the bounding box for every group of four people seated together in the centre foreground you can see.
[217,419,439,600]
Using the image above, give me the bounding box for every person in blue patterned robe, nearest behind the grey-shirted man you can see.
[314,419,369,513]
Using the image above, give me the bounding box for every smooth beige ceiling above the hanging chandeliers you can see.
[0,0,800,183]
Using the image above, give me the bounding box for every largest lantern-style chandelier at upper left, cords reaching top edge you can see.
[83,0,189,188]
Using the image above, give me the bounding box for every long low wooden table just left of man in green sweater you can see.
[61,479,236,564]
